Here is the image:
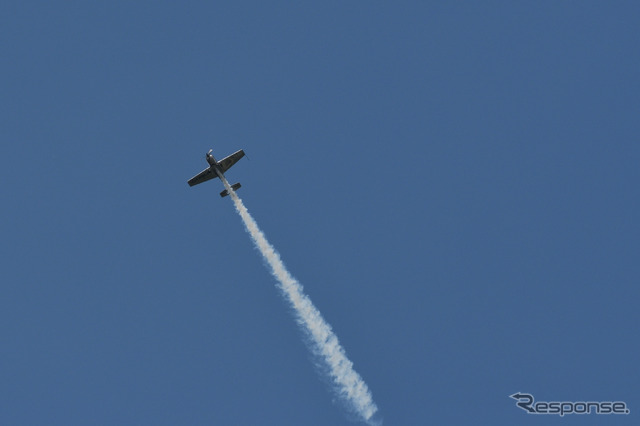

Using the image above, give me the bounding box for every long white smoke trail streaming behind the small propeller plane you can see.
[221,176,378,424]
